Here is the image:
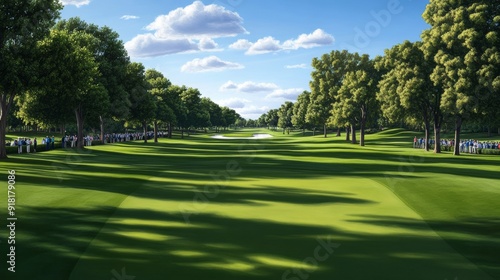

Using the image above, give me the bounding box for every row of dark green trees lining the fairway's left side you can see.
[0,0,241,158]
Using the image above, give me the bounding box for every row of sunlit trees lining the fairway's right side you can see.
[259,0,500,155]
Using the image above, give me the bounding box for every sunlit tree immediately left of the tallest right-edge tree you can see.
[376,41,443,153]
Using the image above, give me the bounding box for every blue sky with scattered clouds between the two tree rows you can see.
[61,0,429,119]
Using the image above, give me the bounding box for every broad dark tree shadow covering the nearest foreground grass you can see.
[8,207,491,280]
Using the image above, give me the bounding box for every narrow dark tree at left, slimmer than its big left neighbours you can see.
[125,62,156,143]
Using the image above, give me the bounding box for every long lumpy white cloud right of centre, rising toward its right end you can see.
[229,29,335,55]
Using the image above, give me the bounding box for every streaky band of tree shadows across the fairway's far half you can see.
[11,138,500,201]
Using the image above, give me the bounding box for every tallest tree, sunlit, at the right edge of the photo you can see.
[422,0,500,155]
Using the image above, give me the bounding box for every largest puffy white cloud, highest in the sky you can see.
[146,1,247,39]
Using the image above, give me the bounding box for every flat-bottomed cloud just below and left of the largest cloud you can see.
[125,34,199,57]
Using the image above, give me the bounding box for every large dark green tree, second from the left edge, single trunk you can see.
[33,30,109,148]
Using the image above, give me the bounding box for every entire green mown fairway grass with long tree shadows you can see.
[0,130,500,280]
